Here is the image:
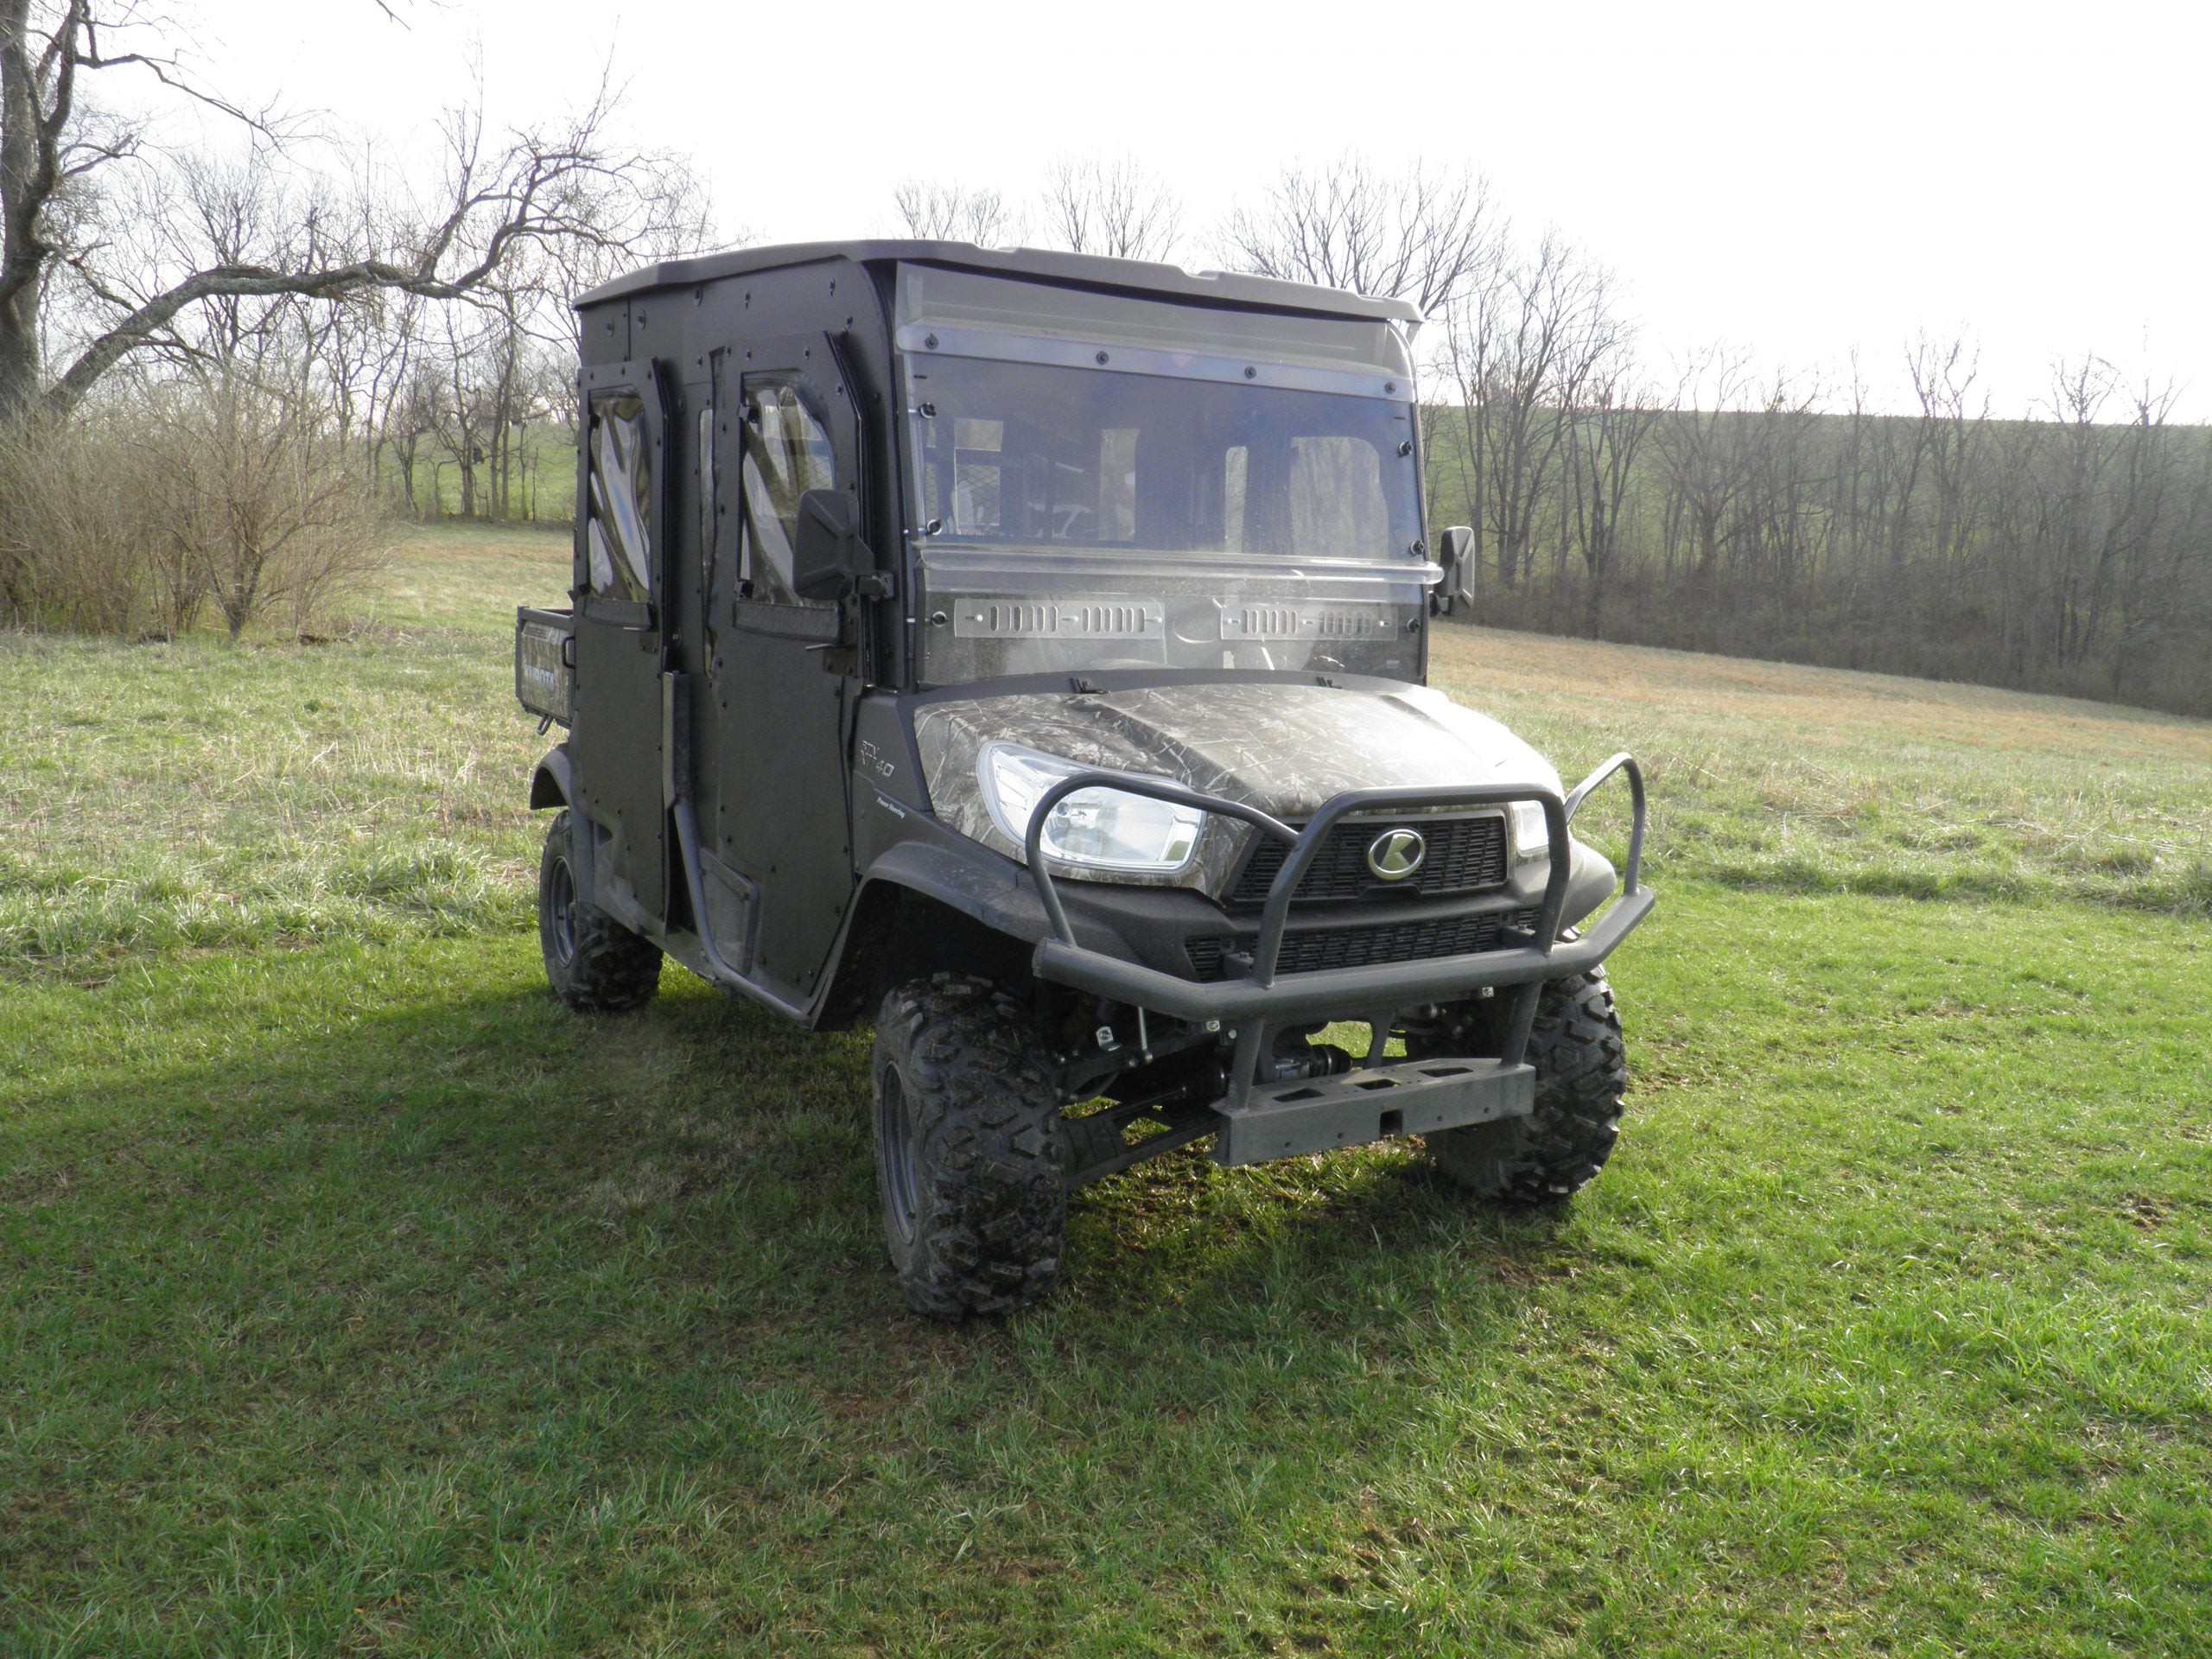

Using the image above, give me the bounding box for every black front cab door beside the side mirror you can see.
[710,334,862,1004]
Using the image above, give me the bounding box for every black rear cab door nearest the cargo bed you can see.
[569,363,668,923]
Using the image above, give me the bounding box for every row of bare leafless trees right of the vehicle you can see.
[1427,340,2212,715]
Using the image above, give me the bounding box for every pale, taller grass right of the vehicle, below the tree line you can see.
[1433,628,2212,916]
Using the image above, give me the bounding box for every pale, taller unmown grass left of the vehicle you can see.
[0,531,569,980]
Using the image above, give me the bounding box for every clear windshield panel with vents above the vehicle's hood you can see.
[909,356,1438,683]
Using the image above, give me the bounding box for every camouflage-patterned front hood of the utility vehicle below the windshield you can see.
[913,681,1560,892]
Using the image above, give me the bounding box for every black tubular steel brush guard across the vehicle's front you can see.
[1027,754,1652,1035]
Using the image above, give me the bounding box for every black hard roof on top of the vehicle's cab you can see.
[575,238,1421,323]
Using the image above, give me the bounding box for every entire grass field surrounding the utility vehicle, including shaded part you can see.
[0,533,2212,1655]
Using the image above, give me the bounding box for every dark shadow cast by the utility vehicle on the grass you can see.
[0,942,1575,1486]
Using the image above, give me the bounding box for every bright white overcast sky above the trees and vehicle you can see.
[147,0,2212,420]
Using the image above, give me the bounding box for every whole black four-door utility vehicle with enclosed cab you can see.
[515,241,1652,1319]
